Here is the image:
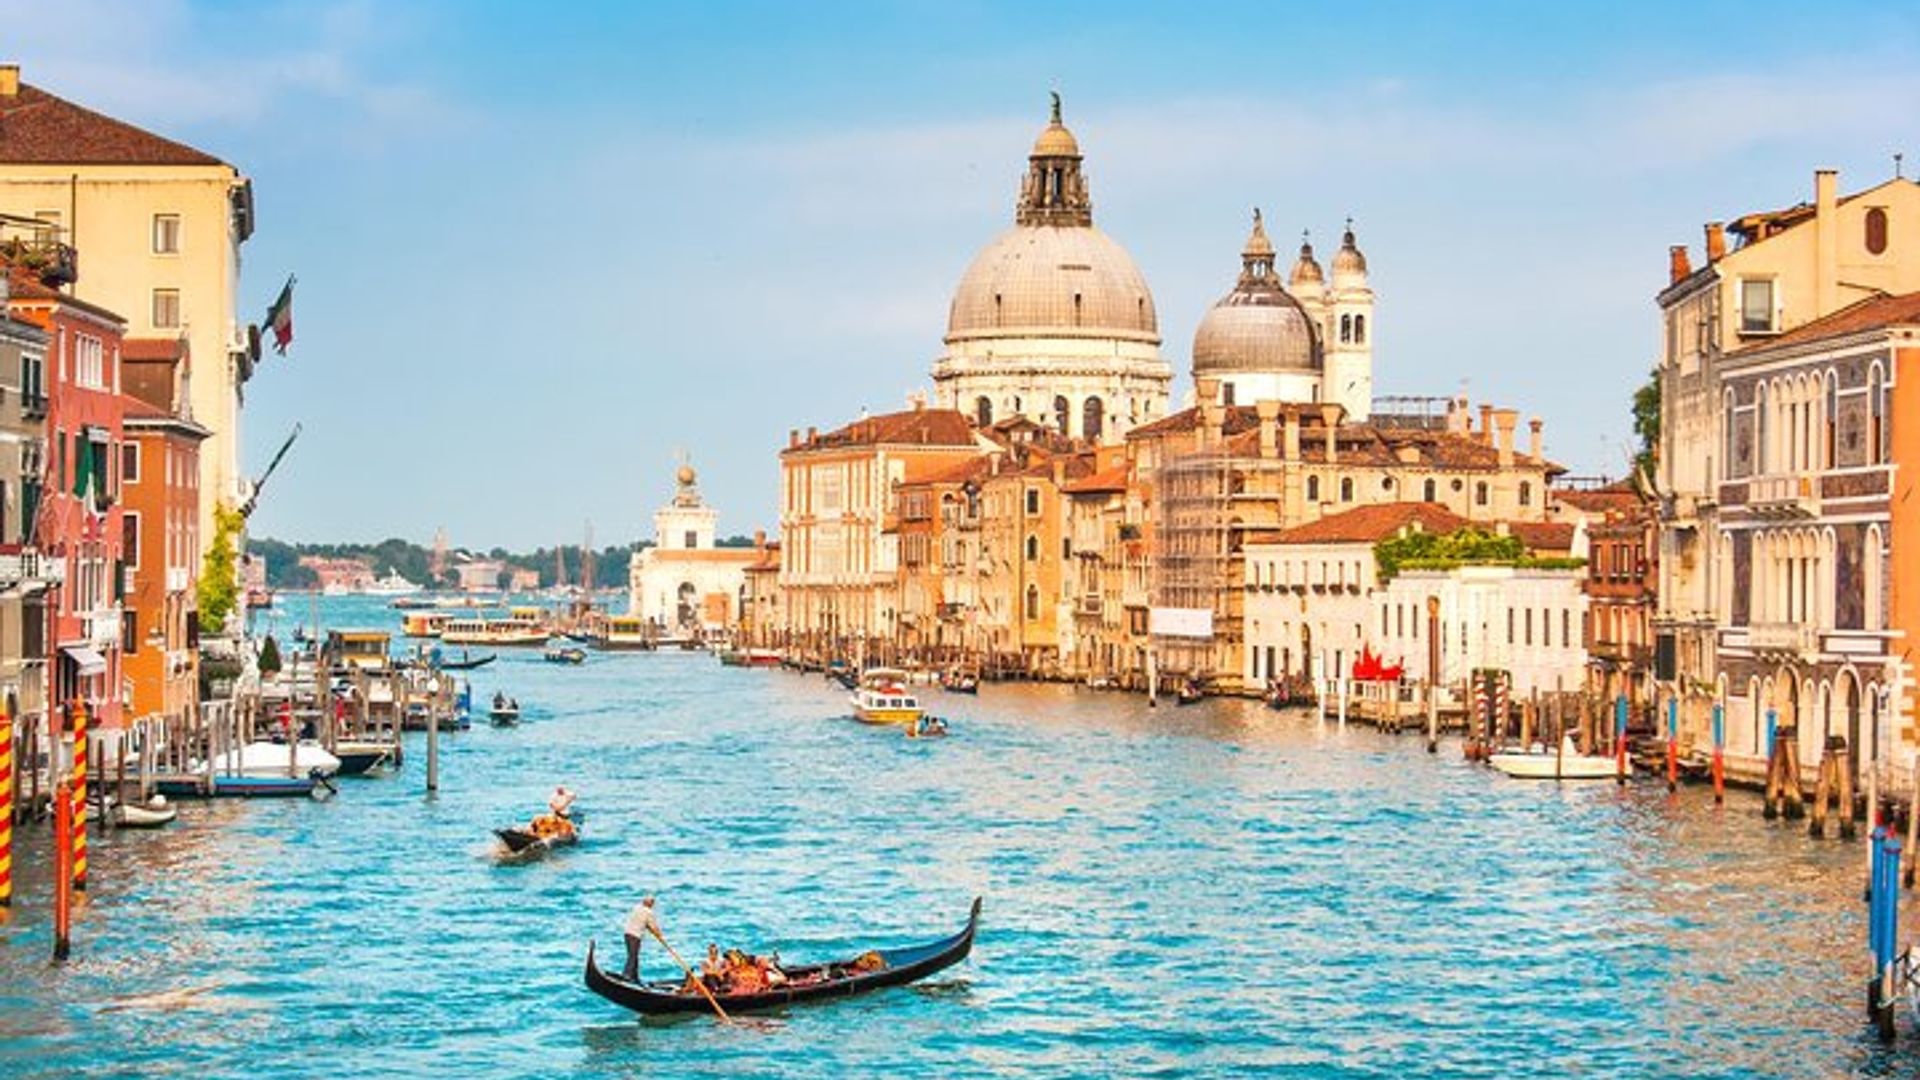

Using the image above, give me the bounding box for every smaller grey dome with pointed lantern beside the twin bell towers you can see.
[1194,215,1323,379]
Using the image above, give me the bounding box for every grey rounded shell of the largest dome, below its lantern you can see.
[947,225,1160,344]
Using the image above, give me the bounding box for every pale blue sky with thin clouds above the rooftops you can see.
[0,0,1920,550]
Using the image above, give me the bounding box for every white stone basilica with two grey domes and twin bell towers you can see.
[933,94,1373,442]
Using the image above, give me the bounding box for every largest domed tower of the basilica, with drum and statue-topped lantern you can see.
[933,96,1173,442]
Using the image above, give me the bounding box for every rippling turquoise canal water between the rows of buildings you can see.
[0,600,1916,1078]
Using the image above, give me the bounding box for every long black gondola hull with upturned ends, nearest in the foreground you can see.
[588,897,979,1017]
